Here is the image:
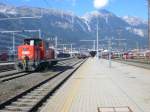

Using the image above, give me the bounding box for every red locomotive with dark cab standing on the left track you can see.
[16,38,57,71]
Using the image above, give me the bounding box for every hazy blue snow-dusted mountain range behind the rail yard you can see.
[0,4,147,47]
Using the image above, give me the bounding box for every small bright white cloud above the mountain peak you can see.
[93,0,109,9]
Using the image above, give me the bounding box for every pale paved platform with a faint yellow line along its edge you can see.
[41,59,150,112]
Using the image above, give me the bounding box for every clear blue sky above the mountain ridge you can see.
[0,0,147,19]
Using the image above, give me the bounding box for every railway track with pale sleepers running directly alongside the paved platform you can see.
[0,60,85,112]
